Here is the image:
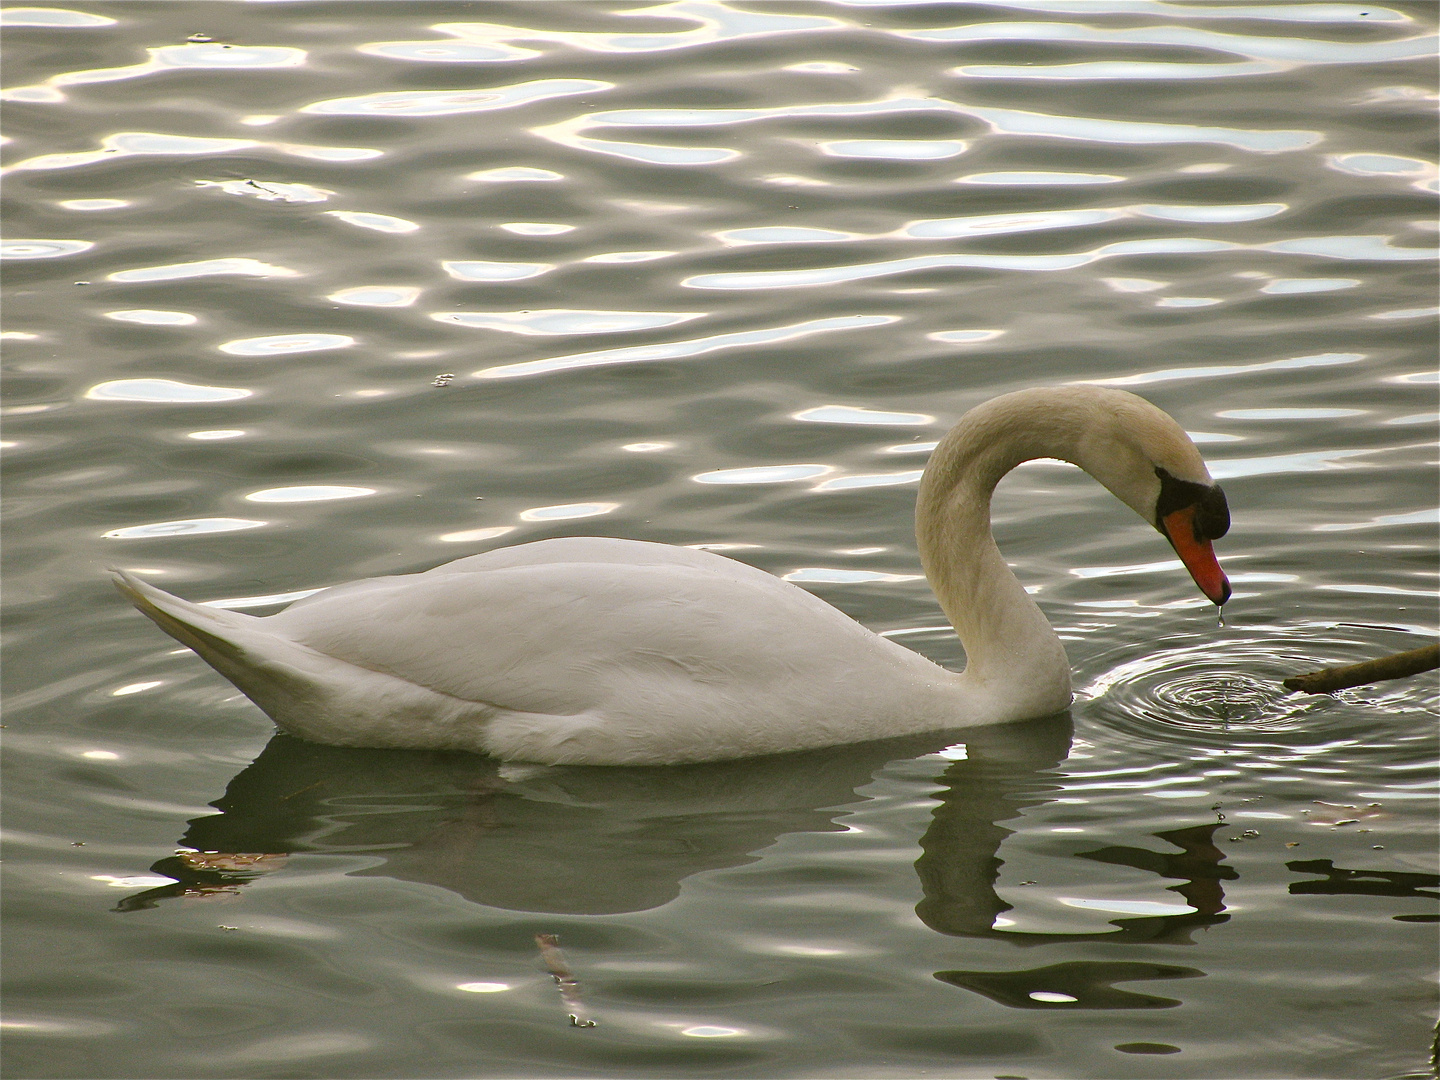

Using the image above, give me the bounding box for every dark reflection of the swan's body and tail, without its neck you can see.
[115,716,1070,914]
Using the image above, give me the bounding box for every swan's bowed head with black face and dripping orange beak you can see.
[1073,387,1230,605]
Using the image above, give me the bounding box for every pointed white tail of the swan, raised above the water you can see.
[111,569,338,727]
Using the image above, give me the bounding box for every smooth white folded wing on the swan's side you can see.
[265,559,914,713]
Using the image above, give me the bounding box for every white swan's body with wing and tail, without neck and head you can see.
[121,540,966,765]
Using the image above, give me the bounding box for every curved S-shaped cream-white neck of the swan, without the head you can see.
[916,392,1083,716]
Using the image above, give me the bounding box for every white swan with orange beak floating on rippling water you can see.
[115,386,1230,765]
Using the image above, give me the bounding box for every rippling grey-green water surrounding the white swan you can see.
[4,0,1437,1079]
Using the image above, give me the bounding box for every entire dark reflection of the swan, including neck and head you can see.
[117,716,1267,1009]
